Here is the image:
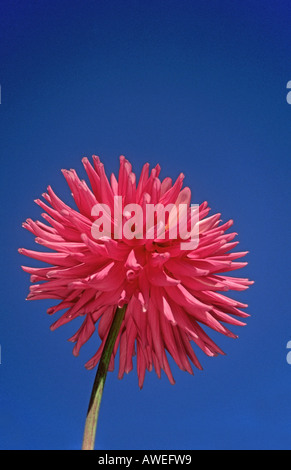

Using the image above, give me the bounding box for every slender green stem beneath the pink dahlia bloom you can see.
[82,305,127,450]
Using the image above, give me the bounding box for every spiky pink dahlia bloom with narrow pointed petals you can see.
[19,156,252,387]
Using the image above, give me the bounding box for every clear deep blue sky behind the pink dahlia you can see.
[0,0,291,450]
